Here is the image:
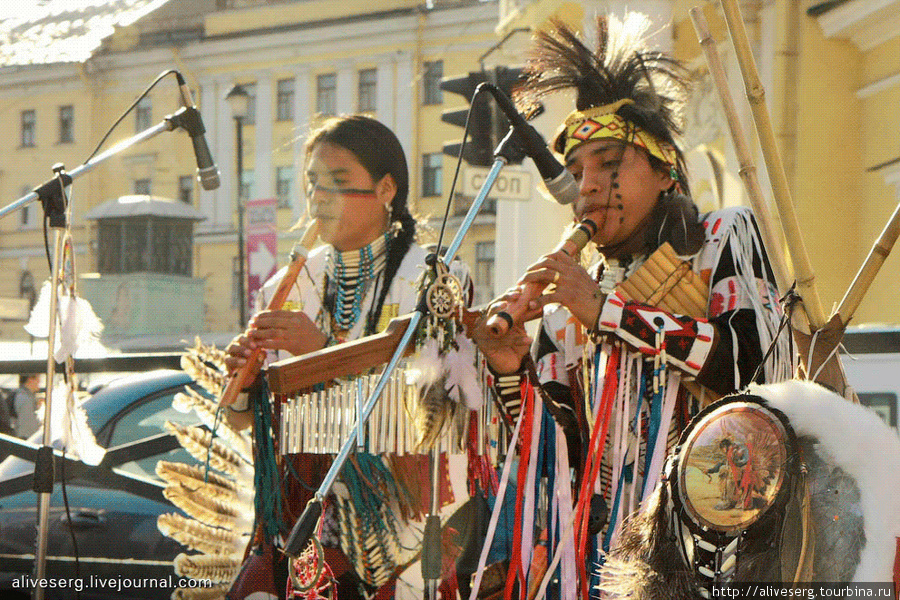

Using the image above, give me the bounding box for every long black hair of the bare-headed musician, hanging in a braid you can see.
[306,115,416,335]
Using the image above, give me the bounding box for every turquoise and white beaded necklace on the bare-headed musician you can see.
[325,233,389,338]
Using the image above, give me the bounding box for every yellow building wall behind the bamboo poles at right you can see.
[498,0,900,325]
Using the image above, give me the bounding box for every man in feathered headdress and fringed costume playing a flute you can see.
[476,15,790,598]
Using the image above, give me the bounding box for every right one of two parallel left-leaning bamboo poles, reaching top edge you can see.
[722,0,825,329]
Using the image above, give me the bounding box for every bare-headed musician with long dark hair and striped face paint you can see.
[227,115,467,600]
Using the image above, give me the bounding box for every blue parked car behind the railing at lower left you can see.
[0,370,207,600]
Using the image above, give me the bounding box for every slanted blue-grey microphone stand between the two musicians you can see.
[284,136,519,600]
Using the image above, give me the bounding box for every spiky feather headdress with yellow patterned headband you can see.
[515,13,704,255]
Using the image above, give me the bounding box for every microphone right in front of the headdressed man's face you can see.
[480,83,578,204]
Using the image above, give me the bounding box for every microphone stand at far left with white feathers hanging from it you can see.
[0,106,210,600]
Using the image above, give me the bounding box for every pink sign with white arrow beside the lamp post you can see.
[244,198,278,308]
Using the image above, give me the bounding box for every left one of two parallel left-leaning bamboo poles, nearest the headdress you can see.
[688,6,793,292]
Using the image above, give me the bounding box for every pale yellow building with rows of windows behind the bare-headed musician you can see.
[0,0,506,350]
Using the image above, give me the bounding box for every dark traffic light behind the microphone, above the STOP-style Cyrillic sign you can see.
[441,67,524,167]
